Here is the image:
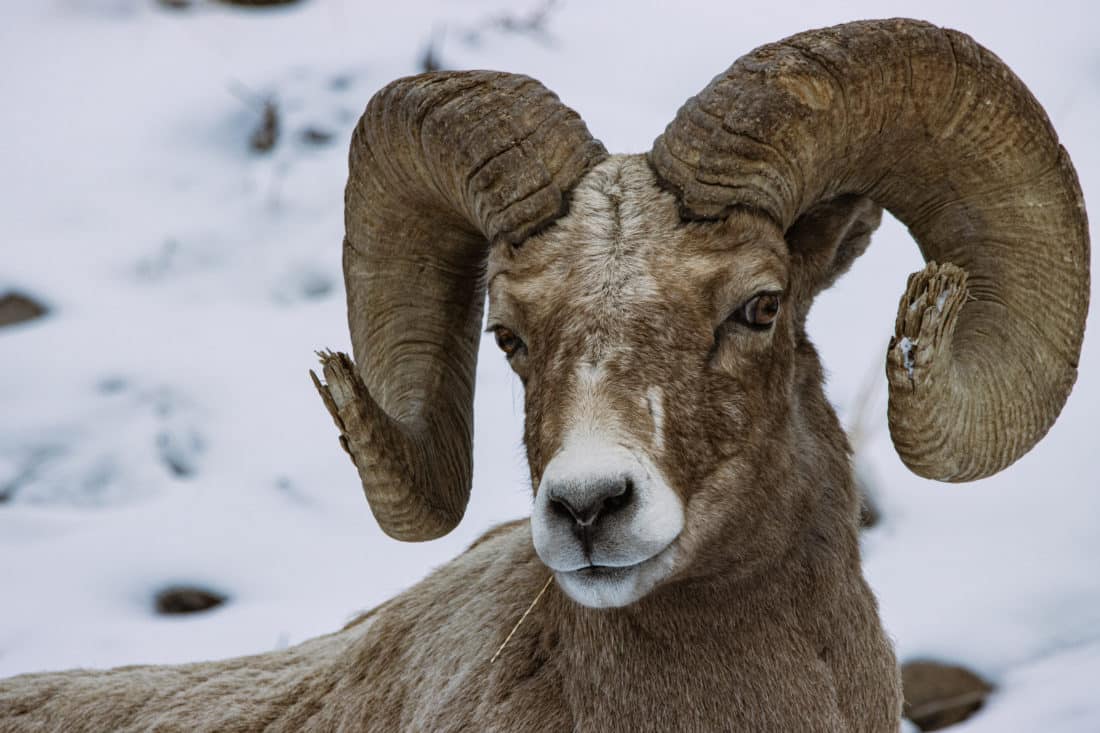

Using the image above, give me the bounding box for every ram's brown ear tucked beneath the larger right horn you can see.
[785,195,882,308]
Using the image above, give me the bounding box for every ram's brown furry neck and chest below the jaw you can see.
[543,348,880,731]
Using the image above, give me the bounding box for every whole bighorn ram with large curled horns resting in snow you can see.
[0,20,1089,732]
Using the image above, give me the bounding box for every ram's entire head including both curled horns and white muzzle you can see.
[319,21,1088,606]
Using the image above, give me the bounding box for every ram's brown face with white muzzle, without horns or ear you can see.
[488,156,794,608]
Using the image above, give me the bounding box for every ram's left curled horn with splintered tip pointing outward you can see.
[314,72,606,540]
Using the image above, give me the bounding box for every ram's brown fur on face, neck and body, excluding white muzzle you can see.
[0,156,901,733]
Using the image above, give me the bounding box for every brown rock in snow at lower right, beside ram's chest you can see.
[901,660,993,731]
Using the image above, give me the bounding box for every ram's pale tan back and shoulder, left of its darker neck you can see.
[0,523,560,733]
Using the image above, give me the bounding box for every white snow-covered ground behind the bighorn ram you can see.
[0,0,1100,733]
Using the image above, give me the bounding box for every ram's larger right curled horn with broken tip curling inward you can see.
[650,20,1089,481]
